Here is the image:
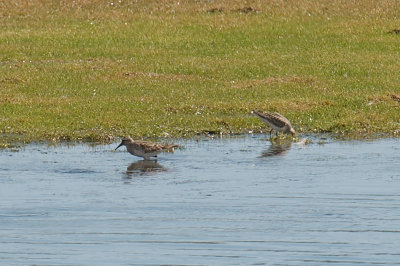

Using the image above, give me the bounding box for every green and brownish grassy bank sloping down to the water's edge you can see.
[0,0,400,145]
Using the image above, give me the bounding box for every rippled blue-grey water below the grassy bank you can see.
[0,135,400,265]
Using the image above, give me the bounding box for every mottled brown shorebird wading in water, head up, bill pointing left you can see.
[115,137,178,160]
